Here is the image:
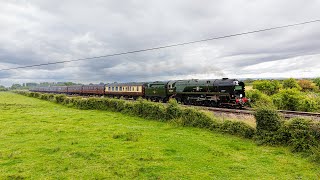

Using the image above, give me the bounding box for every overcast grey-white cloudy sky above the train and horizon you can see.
[0,0,320,86]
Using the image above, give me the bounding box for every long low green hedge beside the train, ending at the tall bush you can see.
[16,91,255,138]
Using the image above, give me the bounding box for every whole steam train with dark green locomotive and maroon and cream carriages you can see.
[30,78,248,107]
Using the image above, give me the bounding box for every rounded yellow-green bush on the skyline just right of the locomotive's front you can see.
[253,80,281,95]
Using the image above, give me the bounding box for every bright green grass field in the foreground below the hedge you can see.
[0,93,320,179]
